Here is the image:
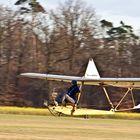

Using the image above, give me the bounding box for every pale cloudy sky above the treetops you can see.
[0,0,140,32]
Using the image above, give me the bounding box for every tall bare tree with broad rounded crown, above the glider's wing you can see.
[51,0,97,70]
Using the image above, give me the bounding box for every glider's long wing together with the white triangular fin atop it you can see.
[20,59,140,88]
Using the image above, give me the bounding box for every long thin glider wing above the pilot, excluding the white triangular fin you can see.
[20,73,140,88]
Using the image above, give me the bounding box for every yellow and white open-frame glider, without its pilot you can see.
[20,58,140,116]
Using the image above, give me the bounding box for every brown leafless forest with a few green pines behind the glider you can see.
[0,0,140,109]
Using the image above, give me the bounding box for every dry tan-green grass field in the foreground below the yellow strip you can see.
[0,114,140,140]
